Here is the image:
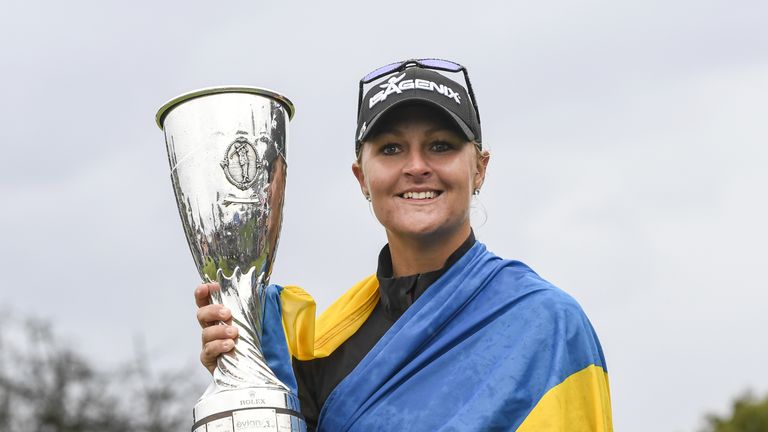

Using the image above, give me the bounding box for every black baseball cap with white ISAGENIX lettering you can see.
[355,66,481,153]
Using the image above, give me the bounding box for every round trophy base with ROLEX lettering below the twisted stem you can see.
[192,387,307,432]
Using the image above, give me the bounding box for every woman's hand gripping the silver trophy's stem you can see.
[195,283,237,373]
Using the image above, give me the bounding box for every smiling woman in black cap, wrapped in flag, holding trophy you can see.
[195,59,612,431]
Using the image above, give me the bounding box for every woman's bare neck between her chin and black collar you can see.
[387,223,471,277]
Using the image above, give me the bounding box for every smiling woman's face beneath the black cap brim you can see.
[352,105,489,238]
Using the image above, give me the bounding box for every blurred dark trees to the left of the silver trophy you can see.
[0,313,205,432]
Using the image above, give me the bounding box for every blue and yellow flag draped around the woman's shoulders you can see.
[267,242,613,432]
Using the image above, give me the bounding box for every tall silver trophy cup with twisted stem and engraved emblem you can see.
[156,87,306,432]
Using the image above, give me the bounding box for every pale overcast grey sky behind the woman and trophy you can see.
[0,0,768,432]
